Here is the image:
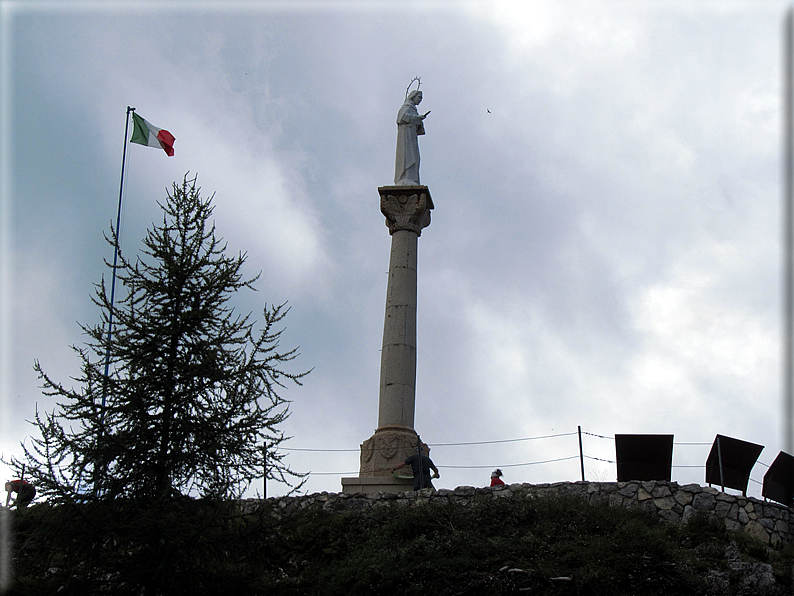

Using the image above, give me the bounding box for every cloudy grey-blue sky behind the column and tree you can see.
[0,0,788,497]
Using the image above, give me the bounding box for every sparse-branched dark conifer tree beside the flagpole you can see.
[11,176,308,502]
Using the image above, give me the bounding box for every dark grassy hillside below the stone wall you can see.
[5,497,794,596]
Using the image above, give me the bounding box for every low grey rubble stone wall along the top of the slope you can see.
[242,481,794,544]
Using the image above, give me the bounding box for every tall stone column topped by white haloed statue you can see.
[342,84,433,493]
